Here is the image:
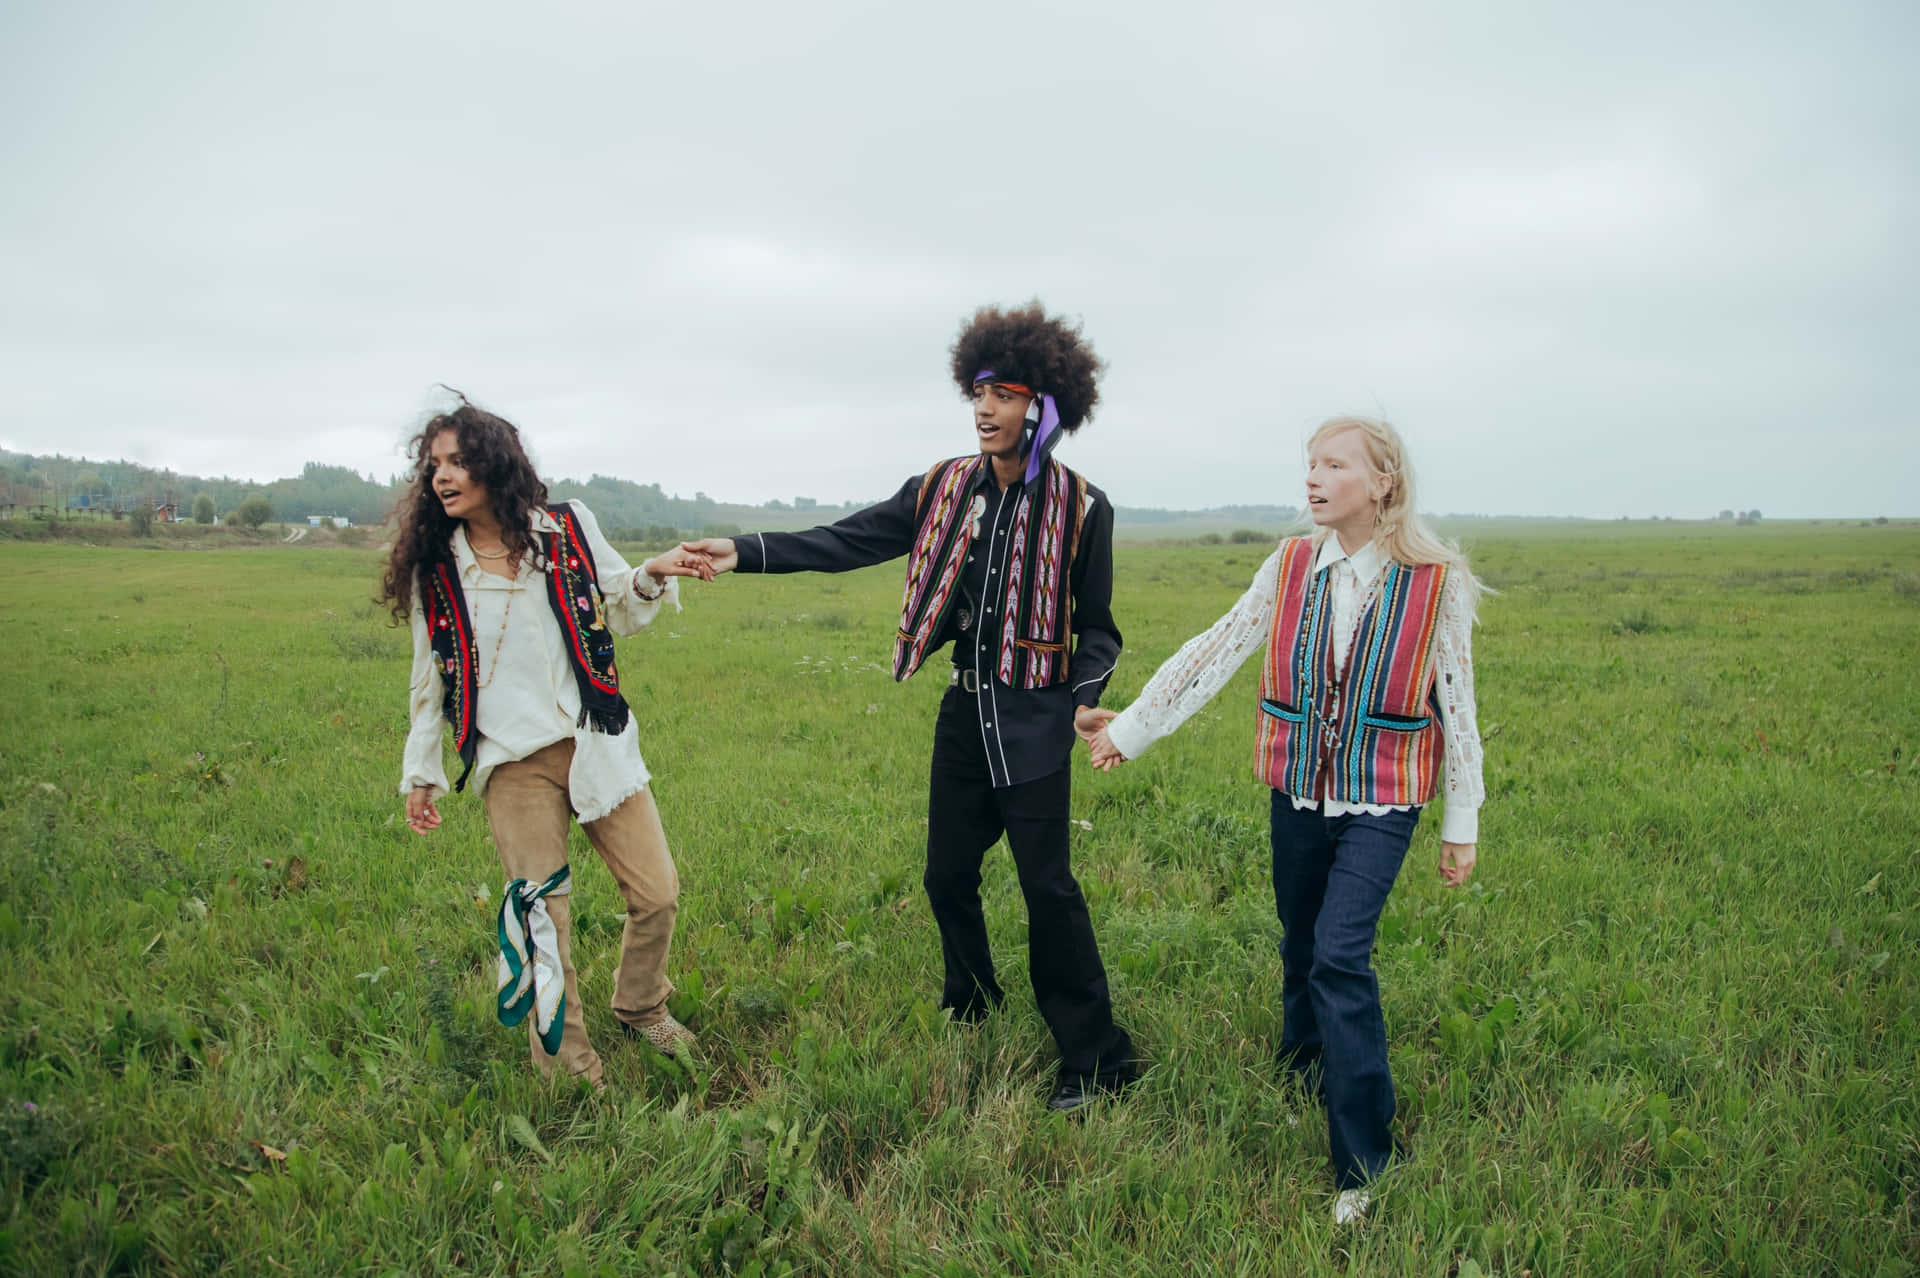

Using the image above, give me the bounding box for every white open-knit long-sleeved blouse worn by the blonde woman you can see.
[1106,535,1486,842]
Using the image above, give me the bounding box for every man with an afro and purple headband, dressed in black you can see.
[685,301,1137,1111]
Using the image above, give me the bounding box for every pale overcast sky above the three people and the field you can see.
[0,0,1920,516]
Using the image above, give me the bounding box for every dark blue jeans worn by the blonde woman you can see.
[1271,791,1421,1190]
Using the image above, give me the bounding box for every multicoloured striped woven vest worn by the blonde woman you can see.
[1254,537,1448,804]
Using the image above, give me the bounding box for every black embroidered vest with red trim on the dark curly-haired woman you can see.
[420,505,628,791]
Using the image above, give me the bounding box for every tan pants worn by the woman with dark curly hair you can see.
[486,741,680,1086]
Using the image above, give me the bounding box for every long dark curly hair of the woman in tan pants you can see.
[374,388,547,622]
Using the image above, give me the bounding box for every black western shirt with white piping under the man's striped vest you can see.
[733,452,1121,787]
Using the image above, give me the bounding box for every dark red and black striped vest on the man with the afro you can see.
[893,453,1089,689]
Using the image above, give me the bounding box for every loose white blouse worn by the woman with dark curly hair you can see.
[399,501,680,821]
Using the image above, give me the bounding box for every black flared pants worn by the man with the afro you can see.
[925,691,1135,1080]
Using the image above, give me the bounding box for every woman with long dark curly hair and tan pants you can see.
[380,395,710,1086]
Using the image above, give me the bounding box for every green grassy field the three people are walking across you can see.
[0,524,1920,1278]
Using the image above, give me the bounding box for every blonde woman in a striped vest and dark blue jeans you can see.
[1089,416,1484,1224]
